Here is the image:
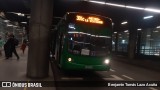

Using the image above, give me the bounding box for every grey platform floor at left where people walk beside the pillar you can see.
[0,48,55,90]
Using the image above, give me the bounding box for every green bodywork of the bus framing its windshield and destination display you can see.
[55,13,112,71]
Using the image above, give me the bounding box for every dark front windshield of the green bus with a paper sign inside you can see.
[68,23,111,56]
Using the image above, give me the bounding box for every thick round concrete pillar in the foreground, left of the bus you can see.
[27,0,53,78]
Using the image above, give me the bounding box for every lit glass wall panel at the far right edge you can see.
[140,28,160,56]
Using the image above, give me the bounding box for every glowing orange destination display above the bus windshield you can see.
[76,15,103,24]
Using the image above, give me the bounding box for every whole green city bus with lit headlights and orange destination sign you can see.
[51,12,112,71]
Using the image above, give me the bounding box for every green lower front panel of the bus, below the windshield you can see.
[60,40,111,71]
